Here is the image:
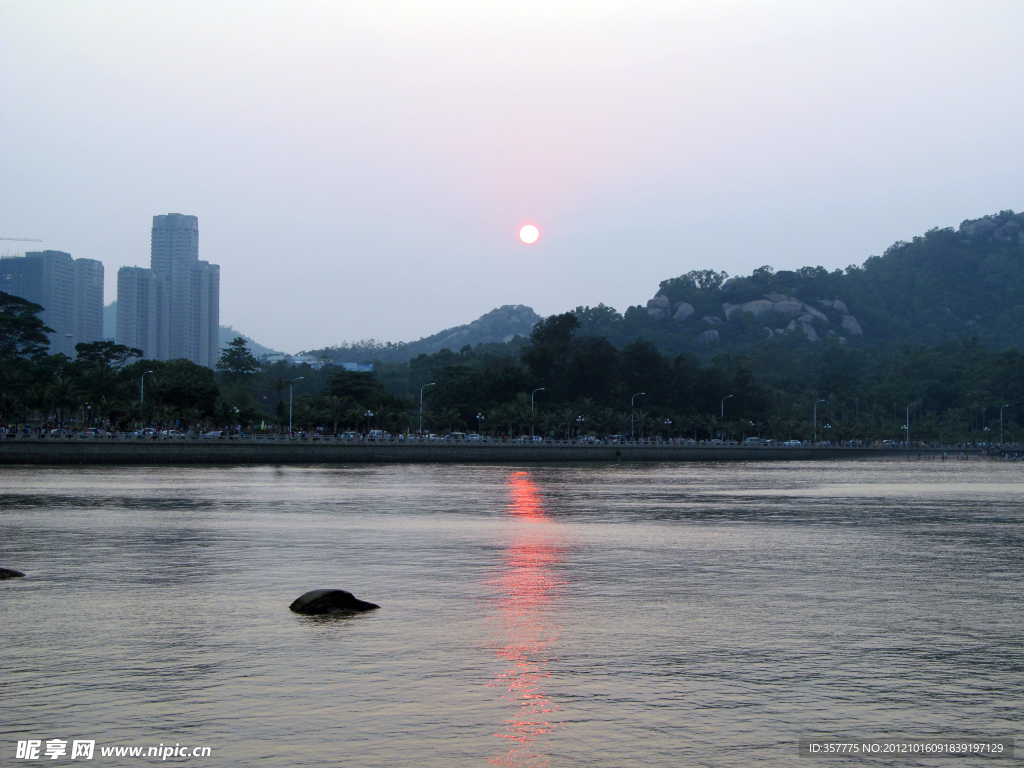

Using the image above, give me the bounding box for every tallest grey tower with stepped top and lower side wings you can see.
[117,213,220,368]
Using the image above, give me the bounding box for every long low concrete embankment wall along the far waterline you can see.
[0,439,956,465]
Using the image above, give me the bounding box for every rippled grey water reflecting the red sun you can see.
[0,461,1024,768]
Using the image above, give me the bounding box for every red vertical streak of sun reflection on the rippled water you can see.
[487,472,564,768]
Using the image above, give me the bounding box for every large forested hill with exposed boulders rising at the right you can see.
[575,211,1024,357]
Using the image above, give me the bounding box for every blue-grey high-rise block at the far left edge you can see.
[0,251,103,357]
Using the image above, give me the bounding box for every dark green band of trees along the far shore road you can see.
[0,294,1024,442]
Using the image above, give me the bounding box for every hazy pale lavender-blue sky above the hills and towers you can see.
[0,0,1024,351]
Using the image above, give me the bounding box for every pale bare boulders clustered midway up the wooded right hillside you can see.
[647,293,864,344]
